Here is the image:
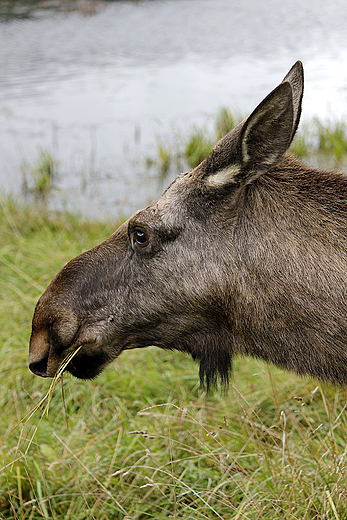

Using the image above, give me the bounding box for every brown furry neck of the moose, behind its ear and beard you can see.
[229,152,347,383]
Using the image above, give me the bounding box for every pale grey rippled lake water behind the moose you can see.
[0,0,347,216]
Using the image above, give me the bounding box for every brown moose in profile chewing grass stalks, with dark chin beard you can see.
[29,61,347,388]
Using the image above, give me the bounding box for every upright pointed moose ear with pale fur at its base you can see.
[201,61,304,187]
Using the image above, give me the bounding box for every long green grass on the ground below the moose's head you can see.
[0,197,347,520]
